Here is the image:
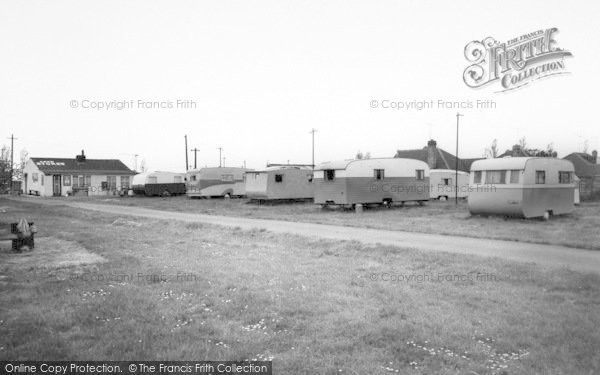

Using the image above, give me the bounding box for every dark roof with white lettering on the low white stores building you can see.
[30,158,135,175]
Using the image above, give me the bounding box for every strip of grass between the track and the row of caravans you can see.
[48,197,600,250]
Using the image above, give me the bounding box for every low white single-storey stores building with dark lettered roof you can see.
[22,150,136,197]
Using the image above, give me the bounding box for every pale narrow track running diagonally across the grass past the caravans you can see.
[9,199,600,274]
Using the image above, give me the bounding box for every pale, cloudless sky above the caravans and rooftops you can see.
[0,0,600,171]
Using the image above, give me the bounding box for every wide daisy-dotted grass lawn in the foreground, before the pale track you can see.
[0,199,600,374]
